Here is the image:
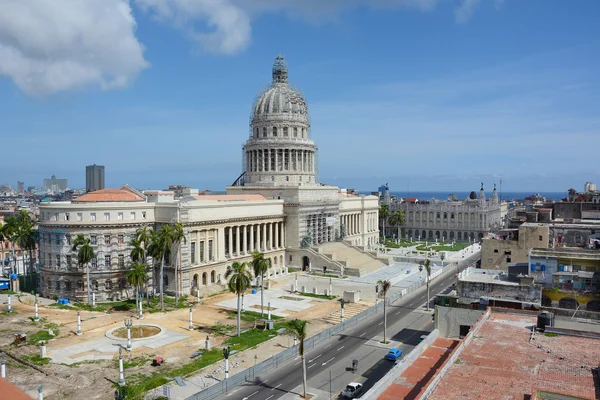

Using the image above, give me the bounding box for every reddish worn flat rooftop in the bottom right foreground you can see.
[429,311,600,400]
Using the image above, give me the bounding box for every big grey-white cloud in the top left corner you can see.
[0,0,149,96]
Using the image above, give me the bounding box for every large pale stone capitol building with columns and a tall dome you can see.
[39,57,385,301]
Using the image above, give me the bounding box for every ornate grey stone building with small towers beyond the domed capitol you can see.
[390,185,507,242]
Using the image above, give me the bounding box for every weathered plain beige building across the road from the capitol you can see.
[481,223,549,270]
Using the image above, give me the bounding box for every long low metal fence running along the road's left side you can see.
[186,255,480,400]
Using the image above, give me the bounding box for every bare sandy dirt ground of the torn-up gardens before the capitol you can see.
[0,276,360,400]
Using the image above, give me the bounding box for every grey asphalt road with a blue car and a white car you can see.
[227,262,466,400]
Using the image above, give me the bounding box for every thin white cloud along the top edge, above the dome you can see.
[133,0,478,54]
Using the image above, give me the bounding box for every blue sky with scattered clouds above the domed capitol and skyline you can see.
[0,0,600,192]
